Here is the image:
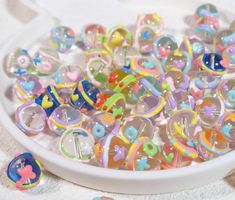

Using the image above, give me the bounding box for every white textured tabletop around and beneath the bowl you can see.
[0,0,235,200]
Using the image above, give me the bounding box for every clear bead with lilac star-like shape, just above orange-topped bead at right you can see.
[196,96,224,127]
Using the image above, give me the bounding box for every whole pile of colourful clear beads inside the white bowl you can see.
[5,4,235,172]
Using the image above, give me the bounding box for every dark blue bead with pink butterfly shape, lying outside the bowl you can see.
[7,153,42,190]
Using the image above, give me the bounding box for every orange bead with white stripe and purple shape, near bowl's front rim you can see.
[95,134,128,169]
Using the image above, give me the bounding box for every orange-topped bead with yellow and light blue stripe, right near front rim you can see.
[197,129,230,160]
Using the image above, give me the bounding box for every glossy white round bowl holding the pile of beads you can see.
[0,0,235,194]
